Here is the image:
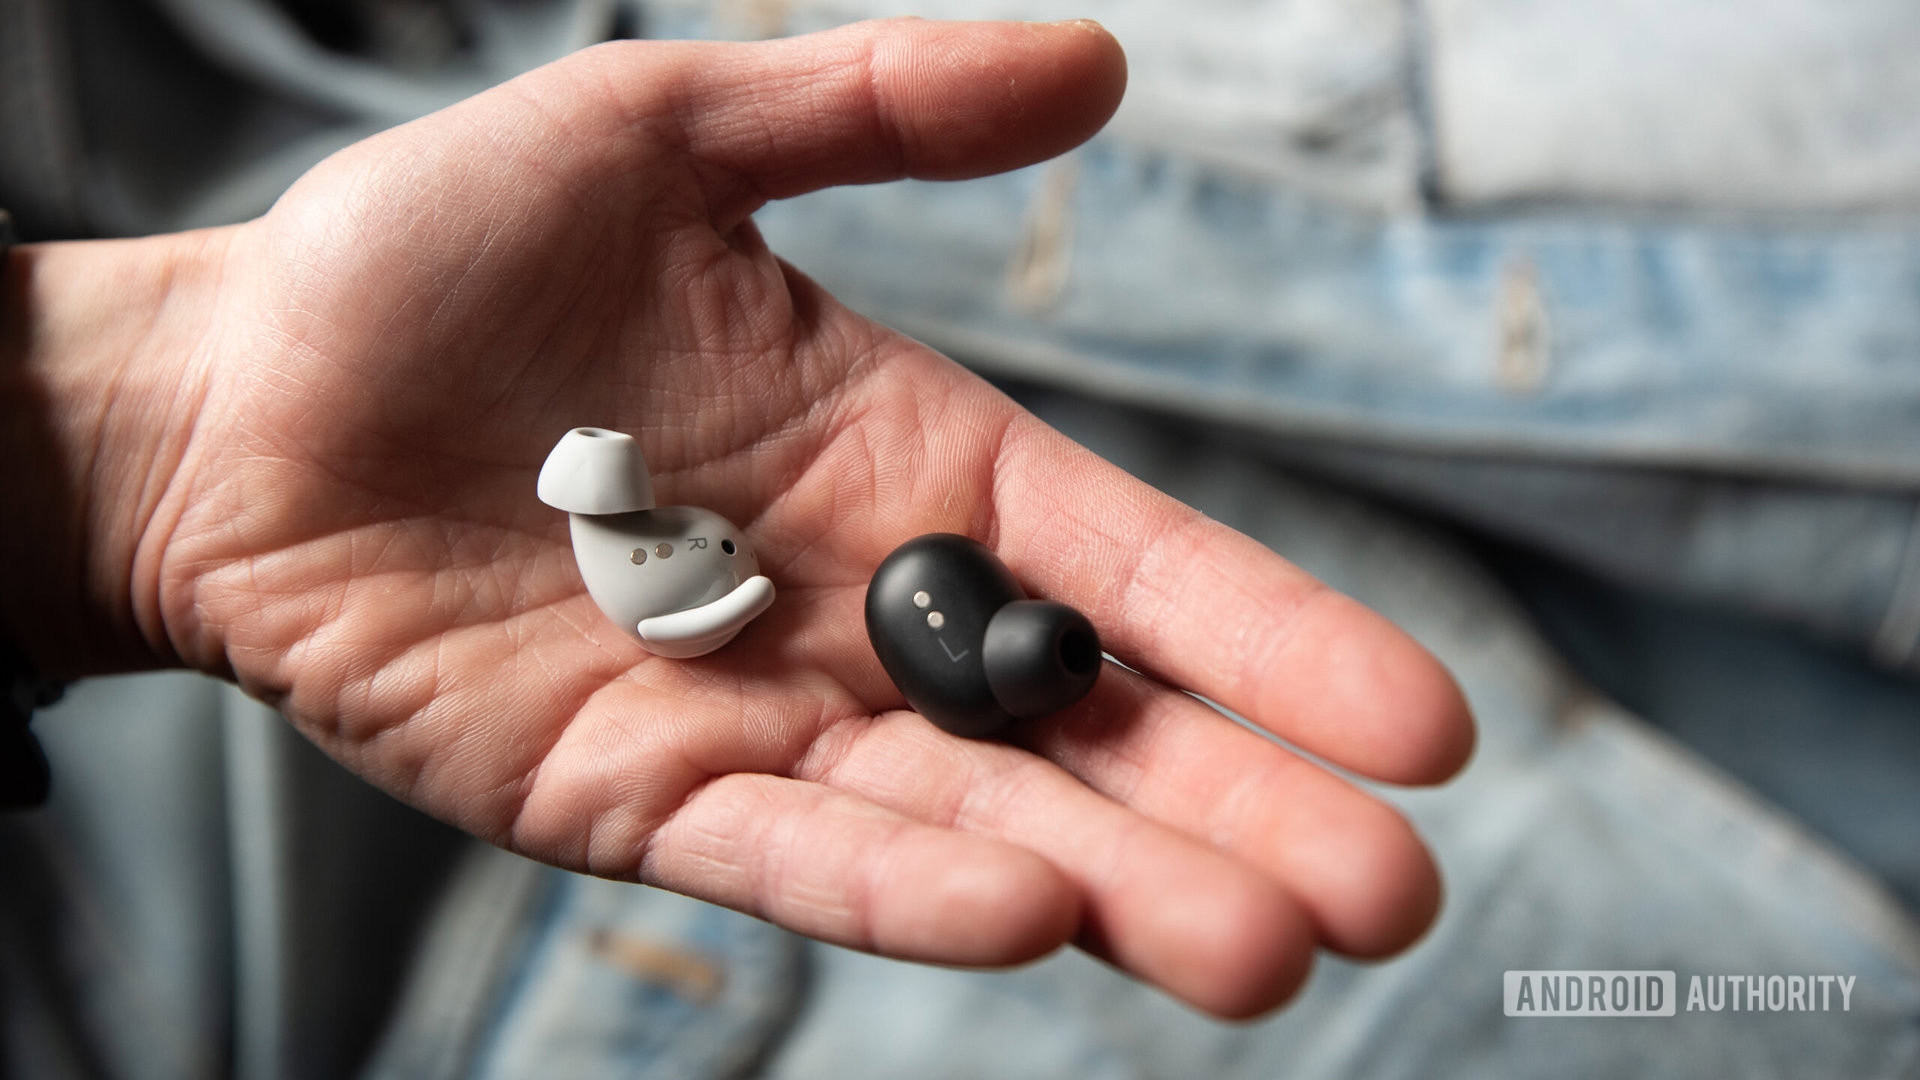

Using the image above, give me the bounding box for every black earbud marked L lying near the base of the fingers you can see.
[866,532,1100,736]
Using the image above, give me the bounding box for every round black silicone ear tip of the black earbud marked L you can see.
[981,600,1100,721]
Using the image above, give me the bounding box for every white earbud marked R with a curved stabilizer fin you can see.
[538,427,774,657]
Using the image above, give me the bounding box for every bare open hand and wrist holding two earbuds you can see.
[0,21,1473,1017]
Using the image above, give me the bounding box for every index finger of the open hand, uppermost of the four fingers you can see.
[989,411,1473,784]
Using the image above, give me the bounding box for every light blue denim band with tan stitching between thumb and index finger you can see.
[760,152,1920,474]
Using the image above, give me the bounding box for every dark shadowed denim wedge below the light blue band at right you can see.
[1248,445,1920,664]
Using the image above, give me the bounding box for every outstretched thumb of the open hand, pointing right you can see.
[582,19,1127,205]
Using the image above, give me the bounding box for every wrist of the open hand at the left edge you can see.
[0,231,230,678]
